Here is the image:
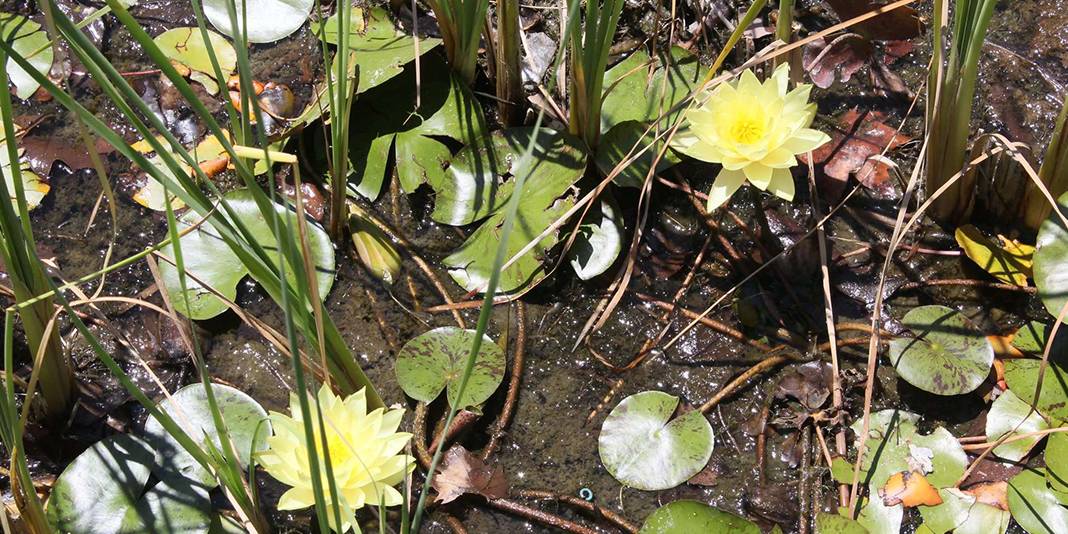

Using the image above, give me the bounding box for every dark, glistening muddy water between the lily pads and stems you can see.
[5,0,1068,533]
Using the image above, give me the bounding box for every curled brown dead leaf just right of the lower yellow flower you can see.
[430,445,508,504]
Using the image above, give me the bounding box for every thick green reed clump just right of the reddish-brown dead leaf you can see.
[925,0,996,224]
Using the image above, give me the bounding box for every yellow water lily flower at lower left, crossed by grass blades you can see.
[260,386,415,533]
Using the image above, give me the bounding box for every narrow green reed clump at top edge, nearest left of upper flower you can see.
[567,0,624,148]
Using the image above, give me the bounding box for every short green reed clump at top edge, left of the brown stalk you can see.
[427,0,489,84]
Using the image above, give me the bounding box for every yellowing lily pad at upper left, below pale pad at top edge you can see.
[153,28,237,95]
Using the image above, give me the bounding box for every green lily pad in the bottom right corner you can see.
[1008,468,1068,534]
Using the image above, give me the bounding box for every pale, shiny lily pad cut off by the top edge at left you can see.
[204,0,315,43]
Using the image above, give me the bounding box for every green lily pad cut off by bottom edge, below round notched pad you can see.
[638,500,760,534]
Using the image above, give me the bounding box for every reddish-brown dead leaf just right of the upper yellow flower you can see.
[800,108,912,200]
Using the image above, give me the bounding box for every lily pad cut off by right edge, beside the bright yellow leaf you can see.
[1034,193,1068,317]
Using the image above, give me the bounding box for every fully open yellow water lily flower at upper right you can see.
[674,64,831,211]
